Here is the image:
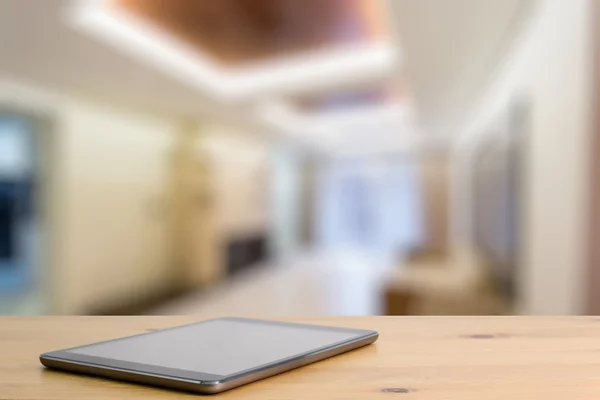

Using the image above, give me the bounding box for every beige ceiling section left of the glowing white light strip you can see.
[0,0,223,116]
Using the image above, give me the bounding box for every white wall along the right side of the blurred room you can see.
[453,0,593,314]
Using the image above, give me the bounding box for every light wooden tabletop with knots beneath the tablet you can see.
[0,316,600,400]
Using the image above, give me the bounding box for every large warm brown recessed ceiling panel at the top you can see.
[113,0,387,65]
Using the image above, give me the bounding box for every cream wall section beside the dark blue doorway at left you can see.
[0,76,179,313]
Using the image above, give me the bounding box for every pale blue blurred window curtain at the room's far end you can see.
[315,159,423,255]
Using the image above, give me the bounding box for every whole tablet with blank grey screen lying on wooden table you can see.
[40,318,379,393]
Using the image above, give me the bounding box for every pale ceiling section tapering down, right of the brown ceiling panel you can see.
[388,0,534,136]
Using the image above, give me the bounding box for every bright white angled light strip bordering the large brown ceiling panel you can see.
[68,0,399,100]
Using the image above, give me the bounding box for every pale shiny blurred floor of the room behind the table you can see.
[149,251,393,316]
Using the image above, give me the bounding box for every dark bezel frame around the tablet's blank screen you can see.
[40,317,378,385]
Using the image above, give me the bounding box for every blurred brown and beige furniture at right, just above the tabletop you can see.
[383,247,512,315]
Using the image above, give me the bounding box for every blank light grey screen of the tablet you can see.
[68,319,359,375]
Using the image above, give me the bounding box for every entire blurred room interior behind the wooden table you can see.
[0,0,600,316]
